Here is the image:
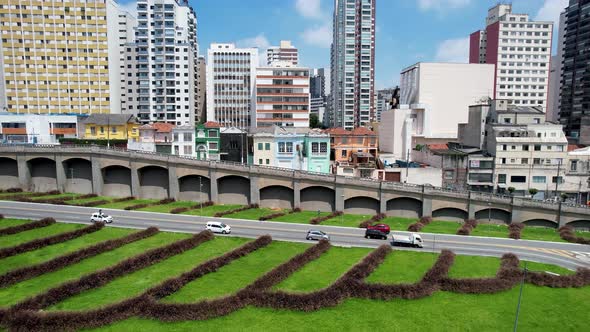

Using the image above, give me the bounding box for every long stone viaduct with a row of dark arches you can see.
[0,145,590,229]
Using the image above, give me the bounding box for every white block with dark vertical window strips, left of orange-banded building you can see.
[207,44,258,129]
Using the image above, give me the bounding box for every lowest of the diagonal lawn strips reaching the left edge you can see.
[0,232,186,306]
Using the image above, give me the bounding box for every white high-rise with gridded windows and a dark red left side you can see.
[469,4,553,109]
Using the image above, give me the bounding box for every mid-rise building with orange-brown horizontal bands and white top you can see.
[256,61,310,128]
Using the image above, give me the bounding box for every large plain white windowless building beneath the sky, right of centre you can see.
[379,62,494,160]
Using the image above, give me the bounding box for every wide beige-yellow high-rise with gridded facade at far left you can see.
[0,0,124,114]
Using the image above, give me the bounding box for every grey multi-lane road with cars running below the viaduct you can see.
[0,201,590,270]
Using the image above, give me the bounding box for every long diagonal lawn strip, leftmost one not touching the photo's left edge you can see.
[49,235,251,310]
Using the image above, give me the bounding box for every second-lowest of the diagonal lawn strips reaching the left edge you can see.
[0,224,135,274]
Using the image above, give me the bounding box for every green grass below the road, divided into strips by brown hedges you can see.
[0,220,590,331]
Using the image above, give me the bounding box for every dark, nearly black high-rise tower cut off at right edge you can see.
[559,0,590,144]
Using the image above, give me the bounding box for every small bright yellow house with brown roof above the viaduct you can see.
[80,114,139,142]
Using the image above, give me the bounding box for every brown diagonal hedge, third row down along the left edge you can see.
[0,227,158,287]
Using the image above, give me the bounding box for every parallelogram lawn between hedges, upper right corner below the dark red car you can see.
[275,247,372,292]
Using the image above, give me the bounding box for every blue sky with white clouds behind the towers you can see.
[118,0,568,89]
